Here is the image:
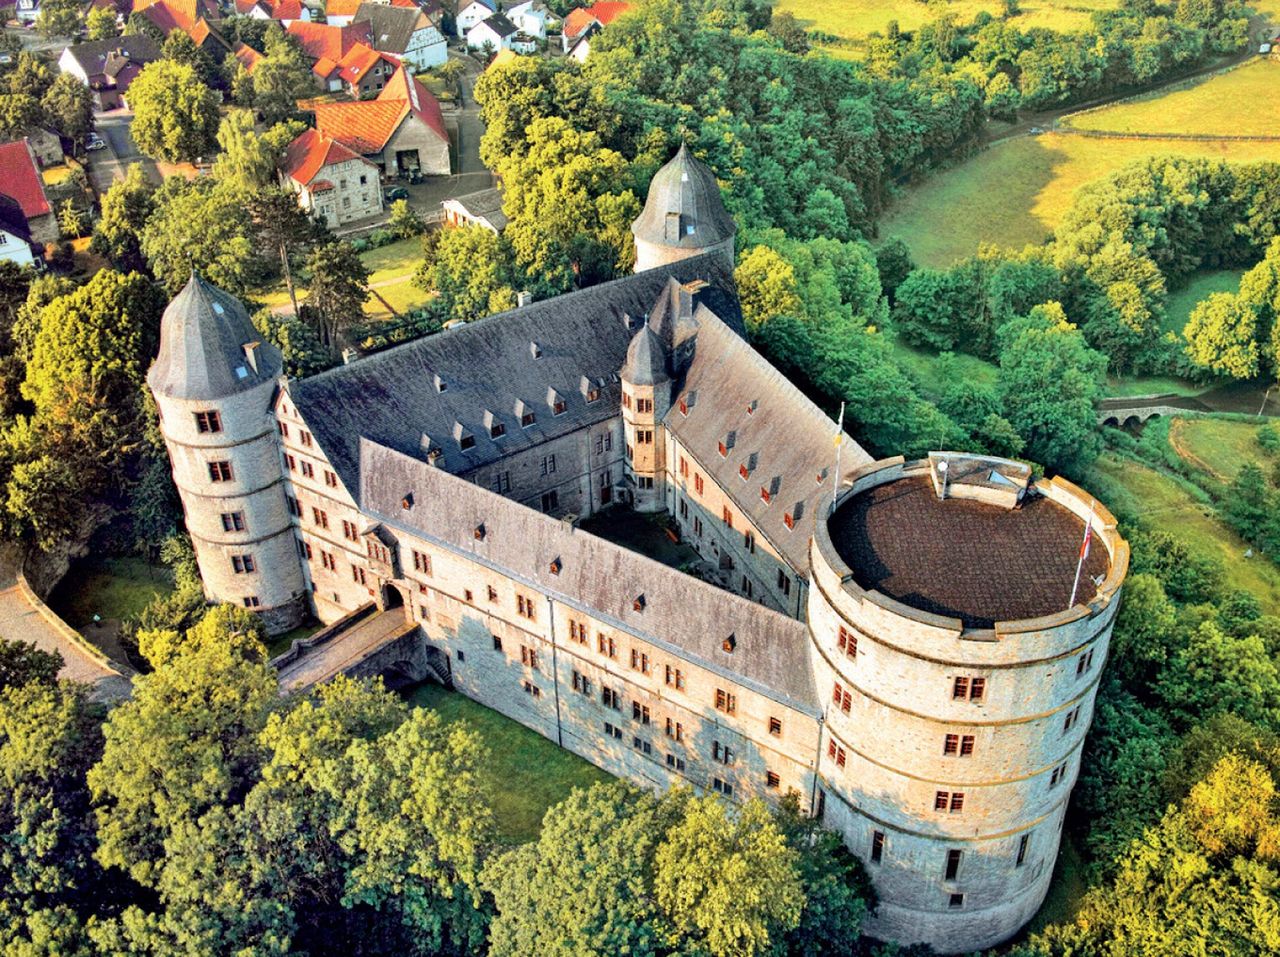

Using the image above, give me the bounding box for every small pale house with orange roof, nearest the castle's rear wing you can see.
[280,129,383,228]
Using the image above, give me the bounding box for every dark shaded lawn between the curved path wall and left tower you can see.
[49,557,173,628]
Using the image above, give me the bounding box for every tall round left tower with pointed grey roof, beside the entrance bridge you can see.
[147,275,307,635]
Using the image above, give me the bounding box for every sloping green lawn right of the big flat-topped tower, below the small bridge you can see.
[1084,454,1280,614]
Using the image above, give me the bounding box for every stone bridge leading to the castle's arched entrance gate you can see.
[271,601,451,693]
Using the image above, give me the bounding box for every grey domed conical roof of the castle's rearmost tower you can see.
[631,143,736,248]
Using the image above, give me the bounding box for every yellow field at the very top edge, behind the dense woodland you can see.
[774,0,1121,47]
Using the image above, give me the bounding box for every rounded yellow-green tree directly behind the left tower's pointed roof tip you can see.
[142,177,262,296]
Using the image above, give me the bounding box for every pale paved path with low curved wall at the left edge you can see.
[0,559,133,701]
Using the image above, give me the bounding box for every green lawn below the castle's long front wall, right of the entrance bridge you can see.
[408,683,613,844]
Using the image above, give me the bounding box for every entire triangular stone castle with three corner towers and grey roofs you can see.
[148,147,1128,952]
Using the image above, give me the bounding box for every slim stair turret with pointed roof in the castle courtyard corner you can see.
[620,322,671,512]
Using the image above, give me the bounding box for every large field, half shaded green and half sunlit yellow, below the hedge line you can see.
[879,133,1280,266]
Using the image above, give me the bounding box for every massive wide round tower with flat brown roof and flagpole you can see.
[809,453,1129,953]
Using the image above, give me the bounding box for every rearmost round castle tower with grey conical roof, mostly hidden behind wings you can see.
[631,143,736,273]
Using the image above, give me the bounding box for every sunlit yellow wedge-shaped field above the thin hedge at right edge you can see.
[1062,59,1280,137]
